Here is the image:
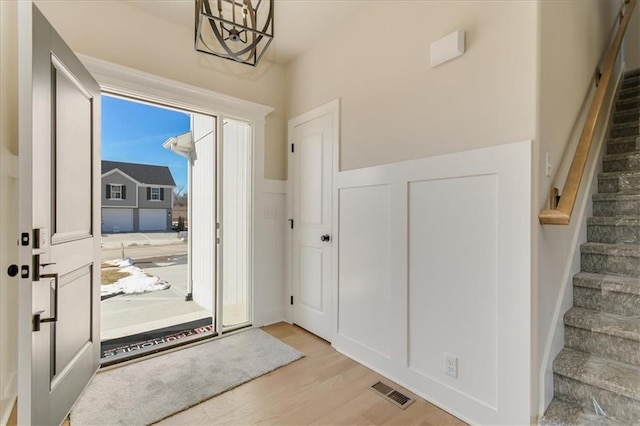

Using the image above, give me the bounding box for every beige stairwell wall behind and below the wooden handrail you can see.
[532,0,624,413]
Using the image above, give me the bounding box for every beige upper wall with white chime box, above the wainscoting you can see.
[286,1,537,170]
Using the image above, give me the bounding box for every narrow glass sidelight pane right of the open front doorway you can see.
[222,120,252,328]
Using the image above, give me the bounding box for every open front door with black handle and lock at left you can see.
[18,2,100,424]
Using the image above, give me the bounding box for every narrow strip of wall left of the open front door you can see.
[0,1,18,424]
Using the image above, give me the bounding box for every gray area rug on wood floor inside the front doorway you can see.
[71,329,304,426]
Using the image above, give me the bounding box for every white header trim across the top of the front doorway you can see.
[78,55,273,120]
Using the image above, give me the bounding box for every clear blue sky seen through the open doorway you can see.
[102,95,191,193]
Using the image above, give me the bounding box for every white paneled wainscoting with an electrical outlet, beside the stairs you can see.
[333,142,532,424]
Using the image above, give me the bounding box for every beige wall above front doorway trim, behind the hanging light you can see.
[36,0,286,179]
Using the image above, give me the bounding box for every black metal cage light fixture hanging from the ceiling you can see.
[195,0,274,66]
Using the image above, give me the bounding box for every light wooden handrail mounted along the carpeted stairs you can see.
[538,0,638,225]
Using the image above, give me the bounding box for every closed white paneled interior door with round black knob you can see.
[289,102,338,341]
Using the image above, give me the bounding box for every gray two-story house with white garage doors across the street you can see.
[102,161,176,233]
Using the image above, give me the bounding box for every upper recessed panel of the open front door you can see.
[52,58,92,239]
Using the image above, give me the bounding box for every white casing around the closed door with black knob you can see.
[285,98,340,340]
